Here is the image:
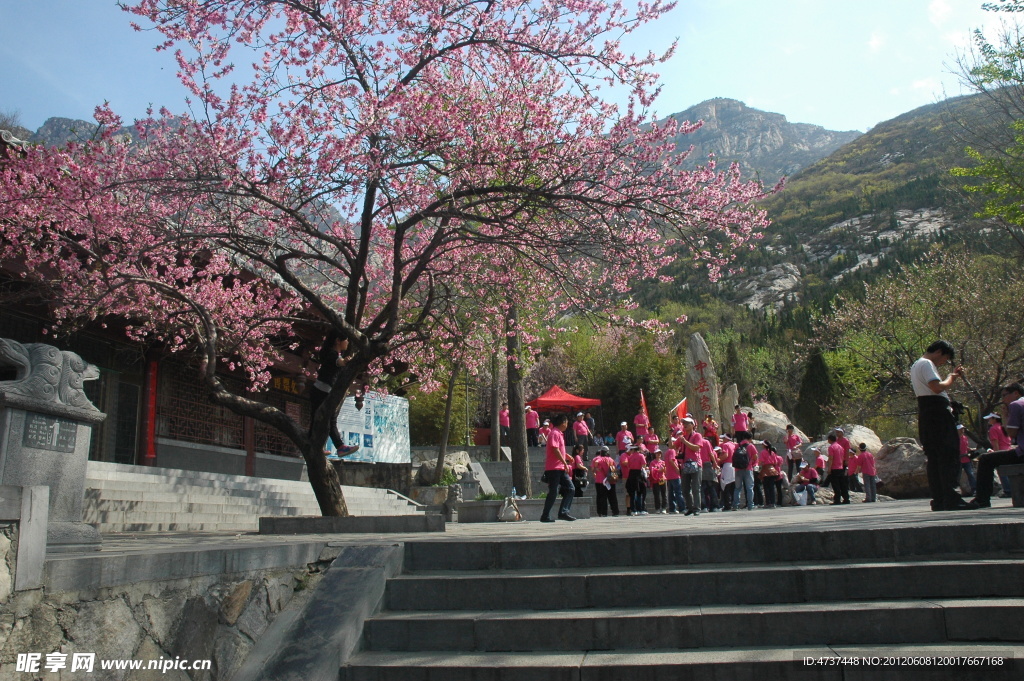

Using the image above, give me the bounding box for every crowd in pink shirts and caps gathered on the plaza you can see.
[539,406,877,522]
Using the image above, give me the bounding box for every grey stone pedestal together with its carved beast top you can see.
[0,338,106,551]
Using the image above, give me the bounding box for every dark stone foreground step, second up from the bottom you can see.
[365,598,1024,652]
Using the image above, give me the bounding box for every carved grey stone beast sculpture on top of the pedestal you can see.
[0,338,99,410]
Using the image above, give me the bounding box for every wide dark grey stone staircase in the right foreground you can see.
[341,520,1024,681]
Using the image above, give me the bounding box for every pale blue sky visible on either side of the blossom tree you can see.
[0,0,1000,130]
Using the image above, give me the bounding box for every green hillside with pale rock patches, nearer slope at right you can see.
[670,91,991,309]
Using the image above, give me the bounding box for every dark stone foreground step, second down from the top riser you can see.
[384,559,1024,610]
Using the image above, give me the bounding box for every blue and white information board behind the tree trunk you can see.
[325,392,413,464]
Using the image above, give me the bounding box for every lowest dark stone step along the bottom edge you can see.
[341,643,1024,681]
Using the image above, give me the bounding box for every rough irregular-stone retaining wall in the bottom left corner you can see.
[0,540,337,681]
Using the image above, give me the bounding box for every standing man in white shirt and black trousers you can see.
[910,340,978,511]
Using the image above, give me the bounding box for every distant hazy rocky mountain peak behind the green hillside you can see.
[655,98,861,185]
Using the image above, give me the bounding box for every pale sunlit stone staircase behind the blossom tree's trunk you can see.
[84,461,422,533]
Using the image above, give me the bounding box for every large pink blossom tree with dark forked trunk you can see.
[0,0,765,515]
